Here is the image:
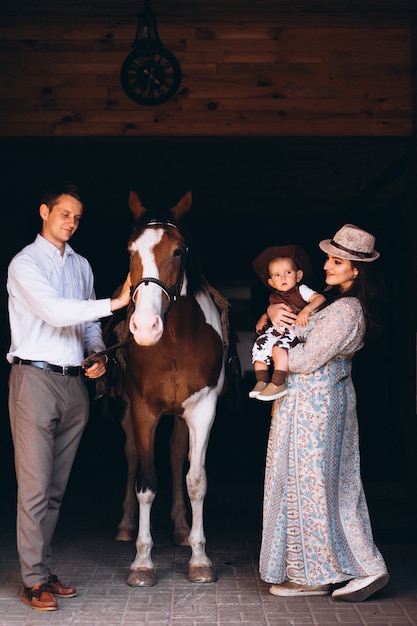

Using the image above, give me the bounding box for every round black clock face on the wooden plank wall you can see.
[120,48,181,106]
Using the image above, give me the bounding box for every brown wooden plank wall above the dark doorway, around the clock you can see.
[0,0,412,137]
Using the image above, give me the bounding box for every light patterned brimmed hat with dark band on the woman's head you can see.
[319,224,379,263]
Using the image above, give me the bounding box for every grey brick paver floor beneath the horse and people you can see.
[0,482,417,626]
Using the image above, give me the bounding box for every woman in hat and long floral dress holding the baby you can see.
[260,224,389,602]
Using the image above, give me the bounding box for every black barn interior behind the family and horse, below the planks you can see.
[1,137,411,530]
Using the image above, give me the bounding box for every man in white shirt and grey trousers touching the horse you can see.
[7,181,130,611]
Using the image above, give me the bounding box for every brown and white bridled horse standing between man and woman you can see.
[119,192,226,586]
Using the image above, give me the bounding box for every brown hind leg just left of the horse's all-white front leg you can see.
[169,416,190,546]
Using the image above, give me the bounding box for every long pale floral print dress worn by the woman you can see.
[259,297,387,585]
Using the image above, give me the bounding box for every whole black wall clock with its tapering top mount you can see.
[120,0,181,106]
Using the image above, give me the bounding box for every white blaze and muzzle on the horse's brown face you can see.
[129,228,164,346]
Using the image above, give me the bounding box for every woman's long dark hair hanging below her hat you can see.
[323,261,388,340]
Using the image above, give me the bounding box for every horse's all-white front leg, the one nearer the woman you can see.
[184,390,217,583]
